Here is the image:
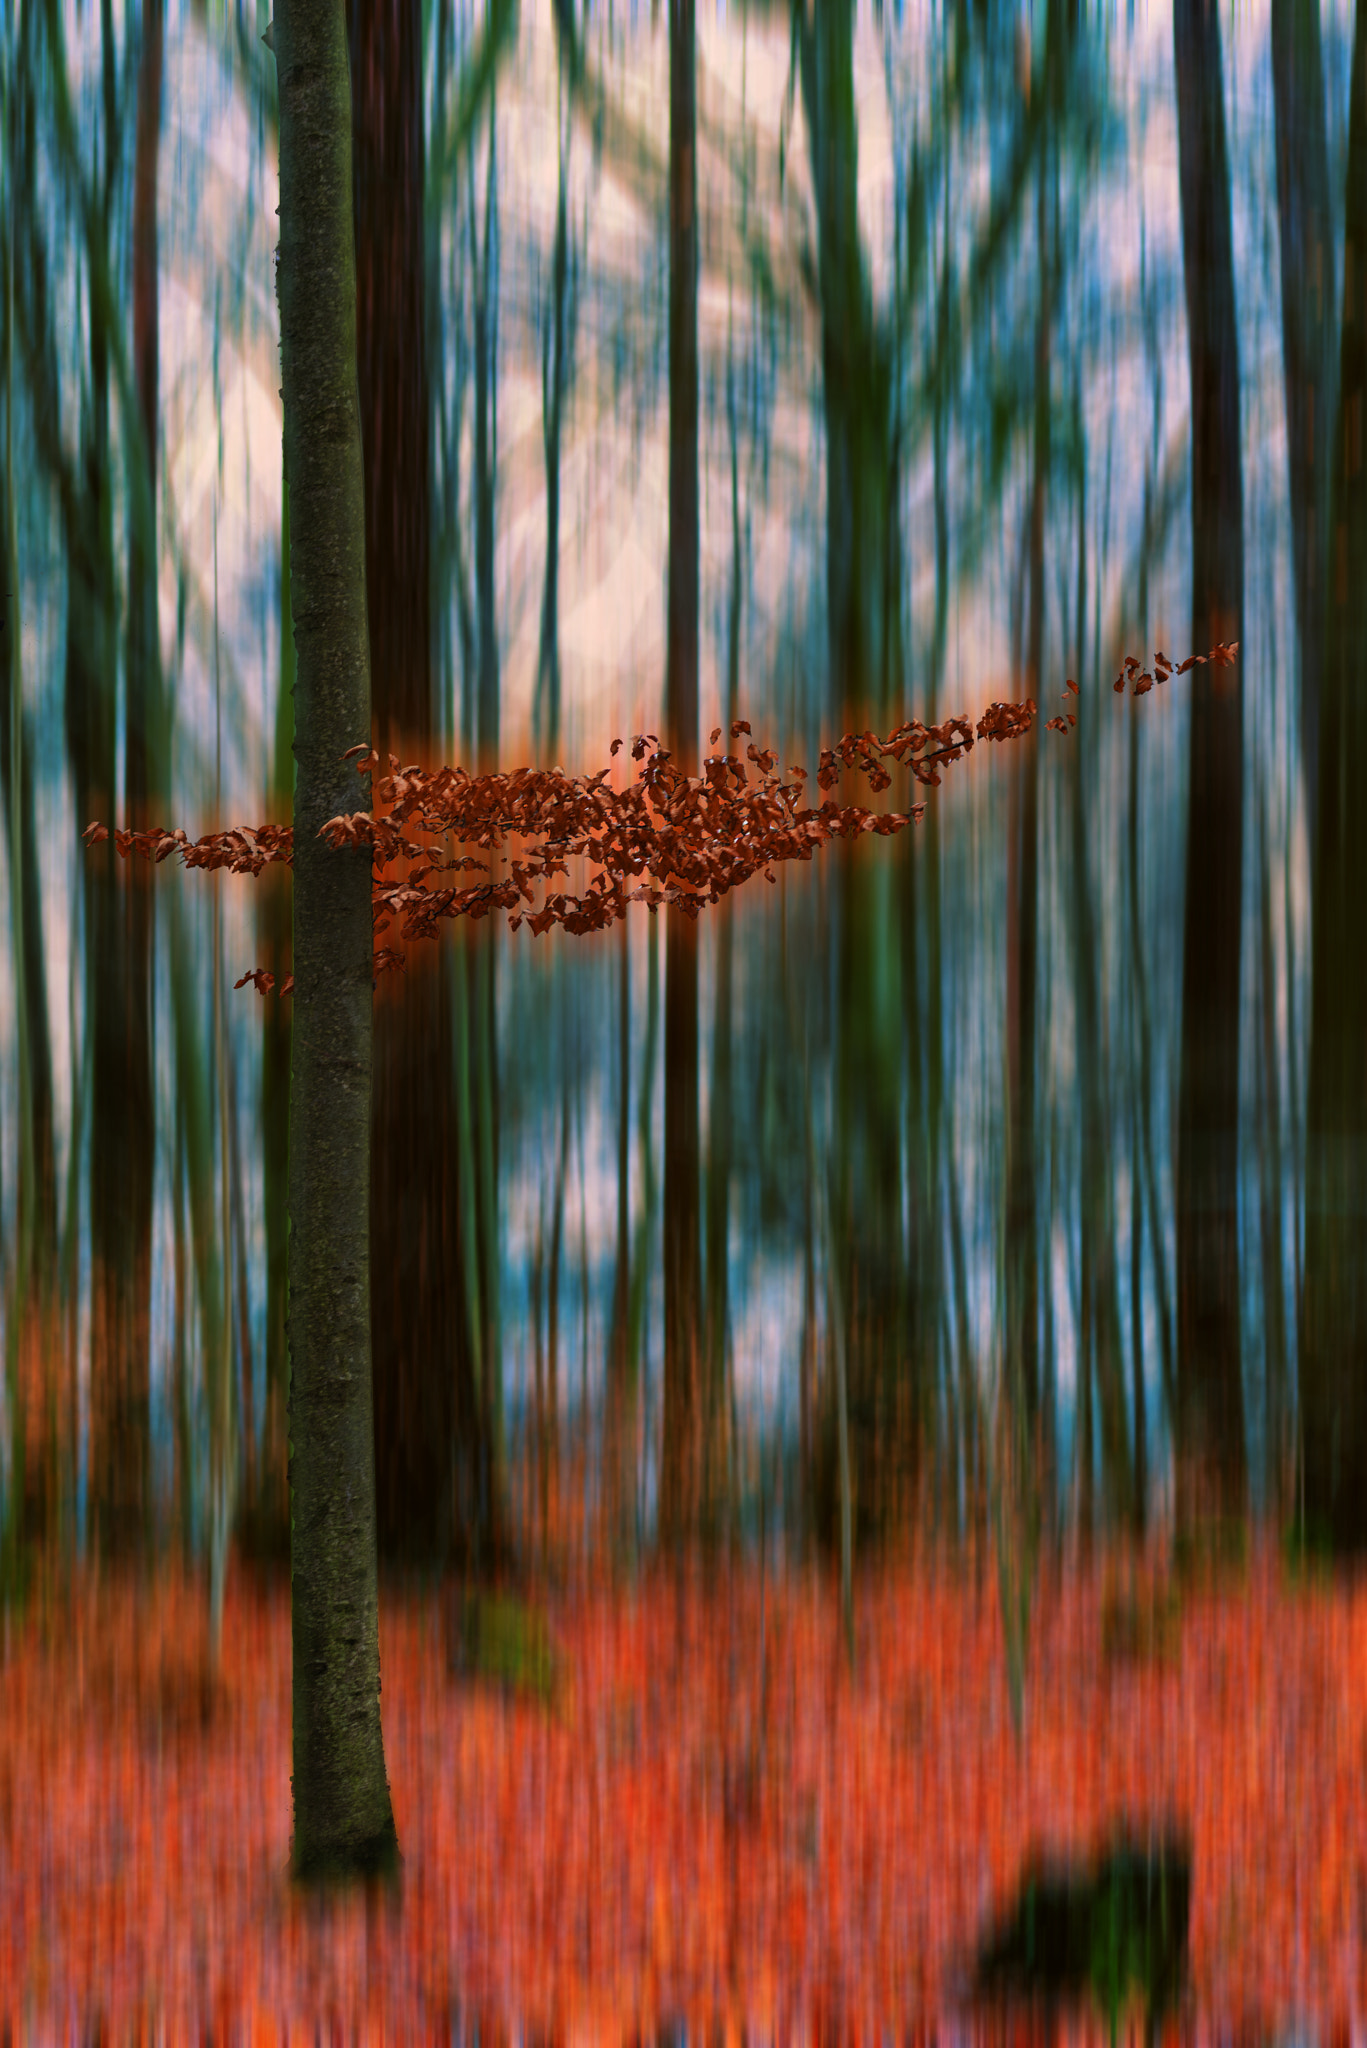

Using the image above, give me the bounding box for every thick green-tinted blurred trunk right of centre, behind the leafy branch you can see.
[793,0,926,1542]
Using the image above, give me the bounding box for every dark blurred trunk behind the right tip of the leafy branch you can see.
[1172,0,1246,1530]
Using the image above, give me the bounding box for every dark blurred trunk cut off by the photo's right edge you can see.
[1299,0,1367,1556]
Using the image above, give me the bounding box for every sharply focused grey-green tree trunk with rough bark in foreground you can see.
[273,0,398,1880]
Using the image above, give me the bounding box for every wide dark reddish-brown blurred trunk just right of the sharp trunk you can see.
[348,0,502,1563]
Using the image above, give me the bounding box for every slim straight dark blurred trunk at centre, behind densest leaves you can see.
[660,0,713,1548]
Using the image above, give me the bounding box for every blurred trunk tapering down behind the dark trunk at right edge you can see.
[1270,0,1334,819]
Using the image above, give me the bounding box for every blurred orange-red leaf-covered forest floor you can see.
[0,1546,1367,2048]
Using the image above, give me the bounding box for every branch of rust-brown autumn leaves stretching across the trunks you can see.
[84,641,1238,995]
